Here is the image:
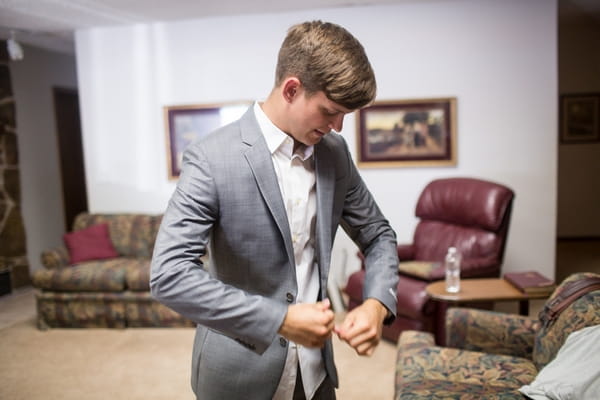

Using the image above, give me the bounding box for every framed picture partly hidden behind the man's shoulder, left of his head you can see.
[164,102,252,179]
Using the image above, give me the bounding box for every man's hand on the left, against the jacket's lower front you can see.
[279,299,334,347]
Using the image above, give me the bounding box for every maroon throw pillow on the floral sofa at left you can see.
[63,224,119,264]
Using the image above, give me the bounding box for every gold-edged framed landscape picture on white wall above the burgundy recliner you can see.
[356,97,457,168]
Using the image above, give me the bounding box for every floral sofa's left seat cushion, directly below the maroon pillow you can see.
[32,258,130,292]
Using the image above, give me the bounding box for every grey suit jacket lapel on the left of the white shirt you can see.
[240,107,294,266]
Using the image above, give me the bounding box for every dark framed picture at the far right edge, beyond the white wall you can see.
[559,93,600,143]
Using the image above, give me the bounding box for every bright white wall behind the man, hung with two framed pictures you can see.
[76,0,557,276]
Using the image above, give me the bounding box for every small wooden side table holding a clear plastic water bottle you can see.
[425,278,549,315]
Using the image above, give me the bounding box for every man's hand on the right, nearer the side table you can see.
[335,299,387,356]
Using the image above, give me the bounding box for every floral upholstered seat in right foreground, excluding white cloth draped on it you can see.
[395,273,600,400]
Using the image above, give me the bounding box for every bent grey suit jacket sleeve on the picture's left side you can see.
[150,140,287,353]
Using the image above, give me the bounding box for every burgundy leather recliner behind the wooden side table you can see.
[344,178,514,344]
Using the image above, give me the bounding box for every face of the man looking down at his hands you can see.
[288,88,352,146]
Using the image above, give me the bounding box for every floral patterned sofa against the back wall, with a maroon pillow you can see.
[32,213,193,329]
